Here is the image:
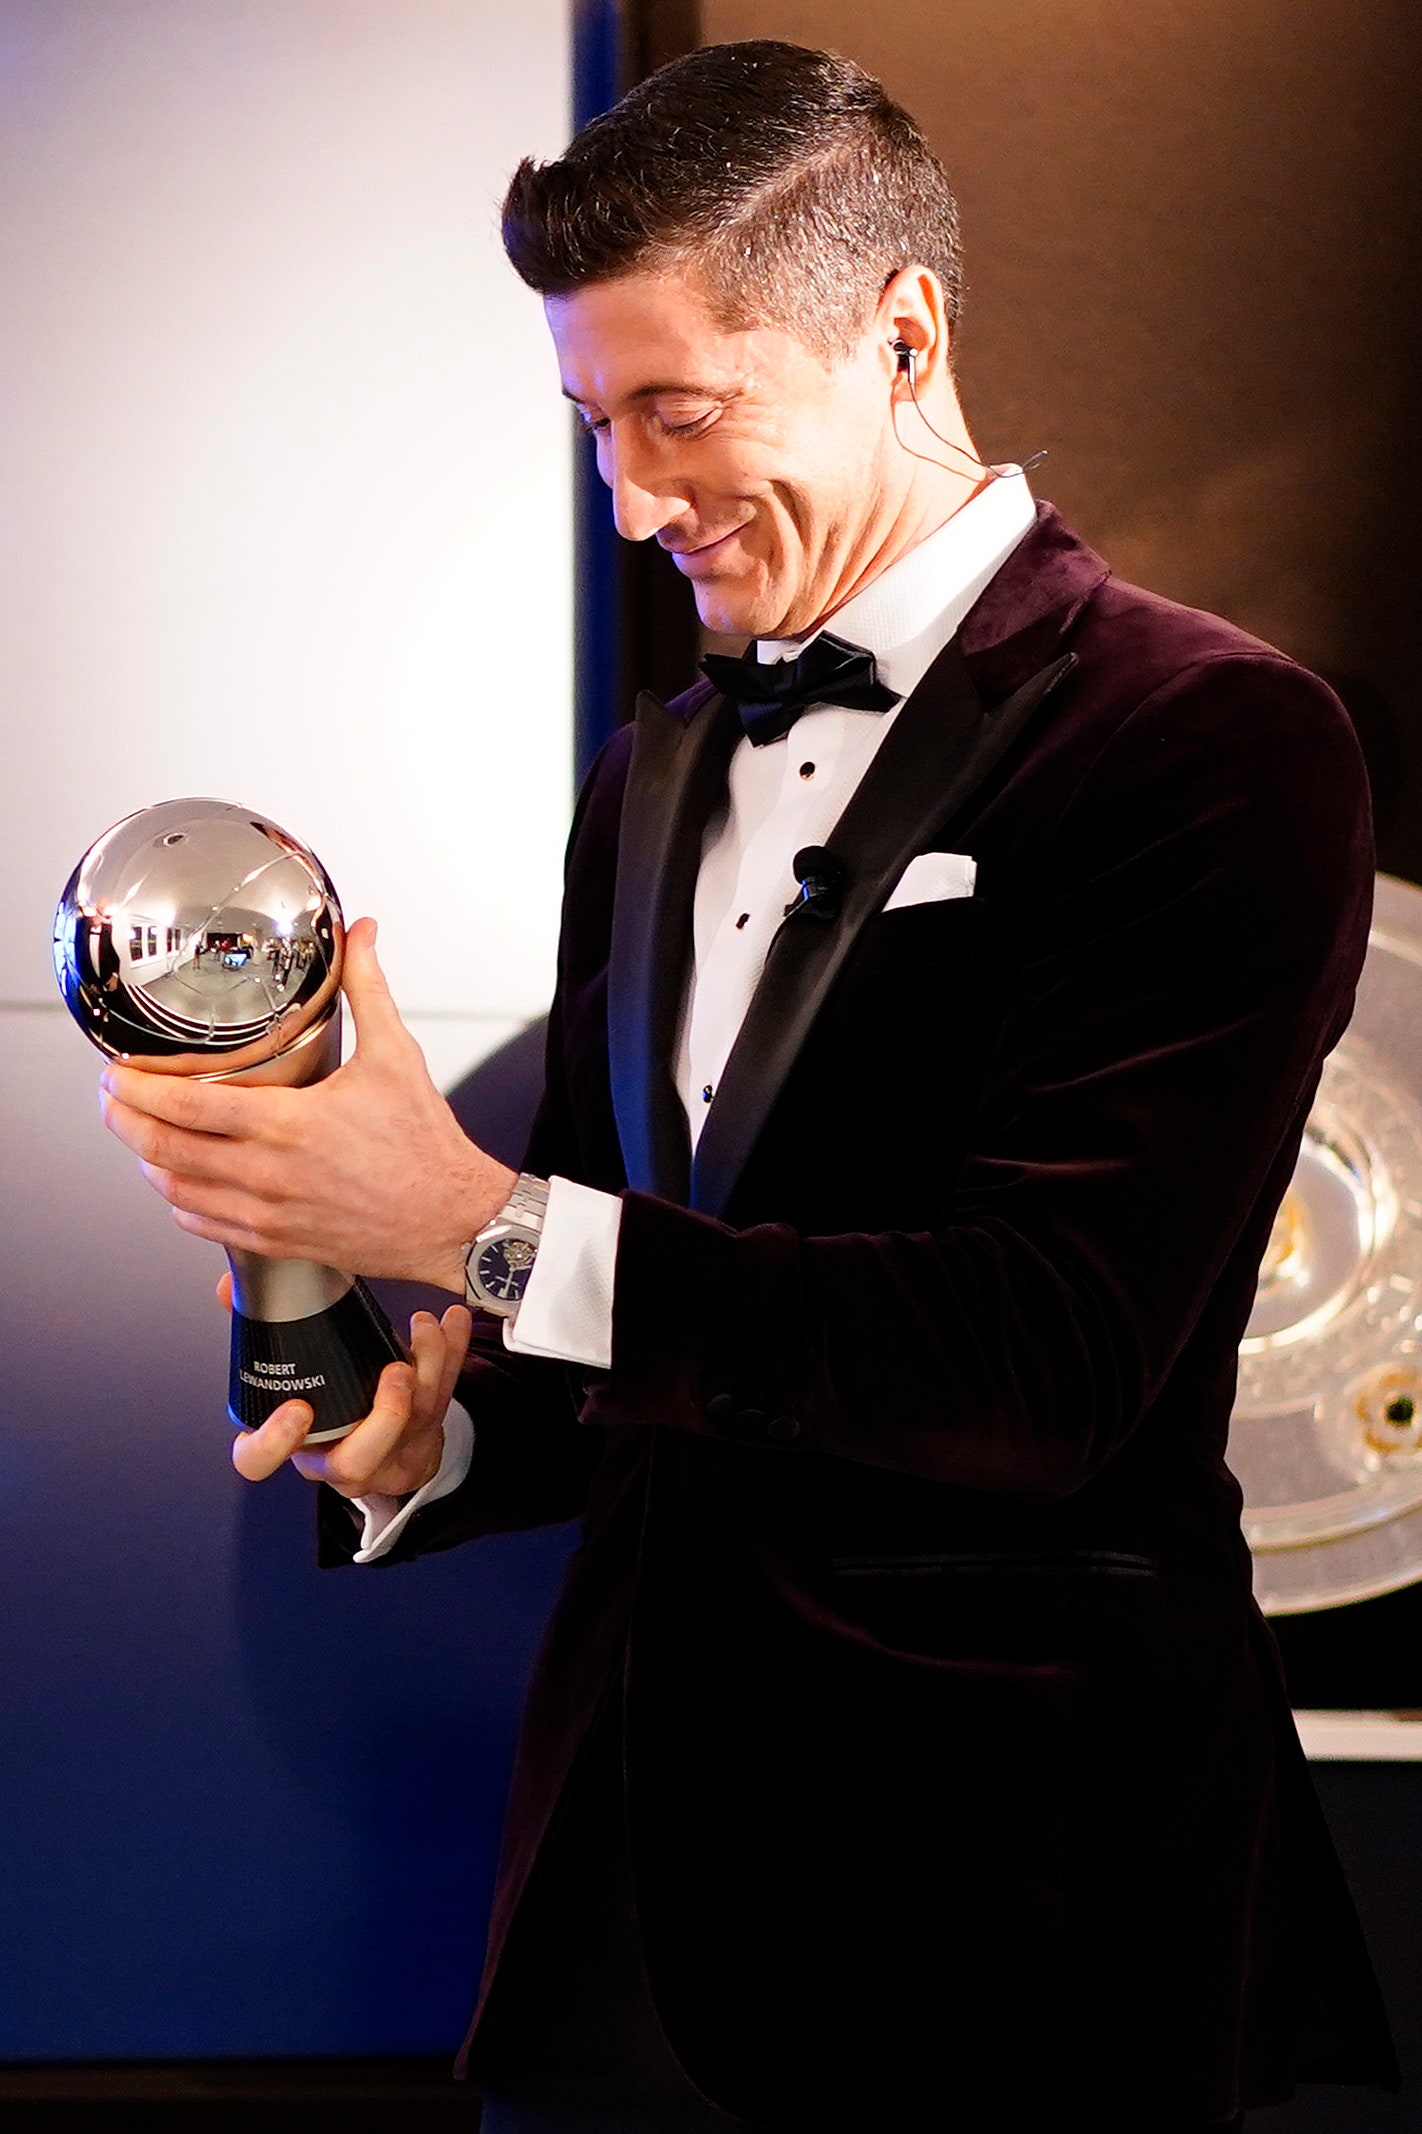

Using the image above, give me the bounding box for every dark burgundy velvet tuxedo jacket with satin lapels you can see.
[325,506,1394,2134]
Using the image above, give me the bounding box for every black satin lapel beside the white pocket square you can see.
[692,638,1076,1214]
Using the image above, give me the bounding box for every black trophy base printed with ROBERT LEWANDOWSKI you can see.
[226,1261,406,1445]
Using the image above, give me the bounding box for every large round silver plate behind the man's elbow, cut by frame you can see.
[1228,875,1422,1615]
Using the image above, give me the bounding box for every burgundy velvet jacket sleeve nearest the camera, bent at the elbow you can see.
[583,653,1373,1500]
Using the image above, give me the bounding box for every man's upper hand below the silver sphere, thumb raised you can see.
[102,920,517,1293]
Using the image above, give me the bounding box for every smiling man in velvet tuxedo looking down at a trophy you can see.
[105,43,1394,2134]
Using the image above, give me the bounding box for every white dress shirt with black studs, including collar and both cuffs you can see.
[345,467,1036,1562]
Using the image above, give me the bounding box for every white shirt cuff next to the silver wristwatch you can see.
[504,1178,621,1370]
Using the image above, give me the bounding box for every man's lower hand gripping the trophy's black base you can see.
[218,1274,474,1496]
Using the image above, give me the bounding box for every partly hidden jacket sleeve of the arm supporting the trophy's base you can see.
[318,728,632,1571]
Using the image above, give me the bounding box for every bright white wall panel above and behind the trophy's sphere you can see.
[0,0,570,1020]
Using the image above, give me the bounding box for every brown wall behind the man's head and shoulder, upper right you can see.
[700,0,1422,879]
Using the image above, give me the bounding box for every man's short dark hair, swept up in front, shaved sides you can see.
[504,38,963,359]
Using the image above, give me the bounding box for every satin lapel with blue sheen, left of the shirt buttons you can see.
[606,694,741,1201]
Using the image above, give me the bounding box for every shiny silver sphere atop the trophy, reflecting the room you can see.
[53,800,346,1080]
